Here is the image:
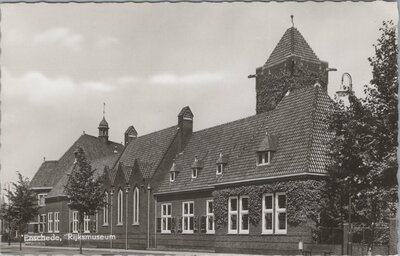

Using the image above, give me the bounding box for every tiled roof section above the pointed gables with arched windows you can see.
[111,126,178,179]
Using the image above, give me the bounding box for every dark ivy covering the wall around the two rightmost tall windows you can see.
[213,180,325,229]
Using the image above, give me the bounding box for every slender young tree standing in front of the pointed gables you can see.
[65,147,105,254]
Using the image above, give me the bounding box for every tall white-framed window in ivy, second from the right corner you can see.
[228,196,249,234]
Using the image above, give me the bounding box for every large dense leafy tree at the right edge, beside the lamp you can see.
[323,21,398,250]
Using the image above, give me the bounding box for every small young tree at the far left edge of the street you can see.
[7,172,38,250]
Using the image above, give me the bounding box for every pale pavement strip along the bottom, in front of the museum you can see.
[0,243,260,256]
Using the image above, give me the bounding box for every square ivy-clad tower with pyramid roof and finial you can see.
[255,15,328,114]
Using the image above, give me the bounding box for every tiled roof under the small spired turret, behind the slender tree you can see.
[43,134,123,196]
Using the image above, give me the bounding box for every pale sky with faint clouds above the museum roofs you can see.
[0,1,398,184]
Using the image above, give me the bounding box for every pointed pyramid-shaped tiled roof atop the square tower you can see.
[264,27,321,67]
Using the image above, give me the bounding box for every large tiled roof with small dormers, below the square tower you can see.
[158,86,331,193]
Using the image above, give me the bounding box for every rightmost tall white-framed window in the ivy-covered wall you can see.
[262,193,287,234]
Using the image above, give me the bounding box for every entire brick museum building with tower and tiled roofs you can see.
[29,24,332,254]
